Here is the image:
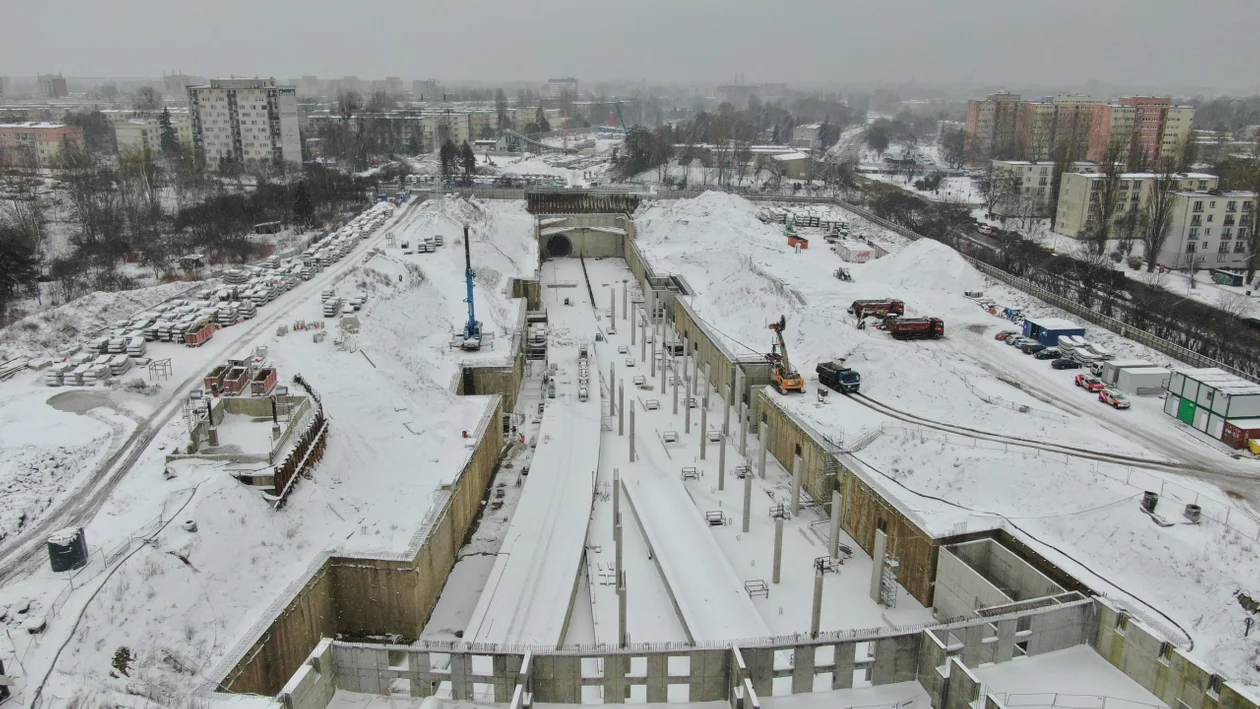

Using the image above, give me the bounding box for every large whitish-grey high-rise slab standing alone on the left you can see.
[188,79,302,162]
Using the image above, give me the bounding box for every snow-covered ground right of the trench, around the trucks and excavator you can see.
[636,193,1260,683]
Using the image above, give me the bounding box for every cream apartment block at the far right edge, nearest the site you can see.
[1157,190,1256,268]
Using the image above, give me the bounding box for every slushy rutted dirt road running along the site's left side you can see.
[0,201,420,584]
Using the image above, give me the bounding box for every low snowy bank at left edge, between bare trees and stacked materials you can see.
[0,281,205,361]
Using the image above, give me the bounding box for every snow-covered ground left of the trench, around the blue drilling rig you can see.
[0,198,537,706]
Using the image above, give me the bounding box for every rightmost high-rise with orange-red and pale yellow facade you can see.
[1087,96,1194,166]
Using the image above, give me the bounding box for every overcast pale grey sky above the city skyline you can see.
[0,0,1260,91]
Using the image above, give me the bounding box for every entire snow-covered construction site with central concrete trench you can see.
[0,190,1260,709]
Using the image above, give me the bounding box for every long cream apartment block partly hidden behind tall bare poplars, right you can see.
[1055,173,1220,238]
